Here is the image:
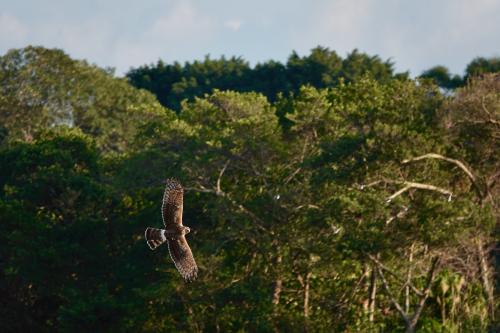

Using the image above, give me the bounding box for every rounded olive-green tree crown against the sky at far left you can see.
[0,46,169,151]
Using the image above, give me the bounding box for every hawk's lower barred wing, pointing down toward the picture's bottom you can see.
[167,236,198,282]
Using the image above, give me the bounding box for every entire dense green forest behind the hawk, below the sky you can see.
[0,46,500,332]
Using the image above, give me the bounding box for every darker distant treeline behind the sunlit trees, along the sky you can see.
[126,46,500,111]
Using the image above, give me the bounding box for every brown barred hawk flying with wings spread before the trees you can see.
[144,179,198,282]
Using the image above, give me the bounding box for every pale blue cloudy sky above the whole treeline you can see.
[0,0,500,75]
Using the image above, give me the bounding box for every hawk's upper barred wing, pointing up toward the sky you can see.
[161,179,184,227]
